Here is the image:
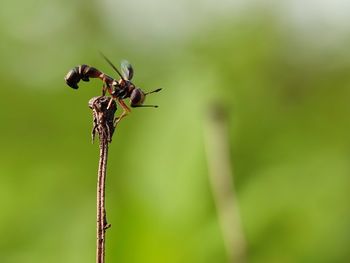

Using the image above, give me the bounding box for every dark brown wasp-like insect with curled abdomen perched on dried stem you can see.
[64,53,161,125]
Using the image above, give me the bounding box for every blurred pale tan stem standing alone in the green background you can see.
[204,104,246,263]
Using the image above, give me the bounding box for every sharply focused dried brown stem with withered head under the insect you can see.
[89,96,117,263]
